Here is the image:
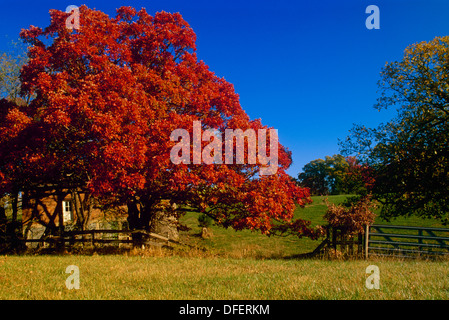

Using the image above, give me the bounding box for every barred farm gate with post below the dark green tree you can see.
[365,224,449,258]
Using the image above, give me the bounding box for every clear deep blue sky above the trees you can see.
[0,0,449,176]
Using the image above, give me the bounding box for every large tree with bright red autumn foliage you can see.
[0,6,317,237]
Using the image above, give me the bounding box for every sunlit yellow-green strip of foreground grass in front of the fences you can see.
[0,255,449,300]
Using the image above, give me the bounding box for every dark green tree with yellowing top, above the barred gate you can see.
[341,36,449,223]
